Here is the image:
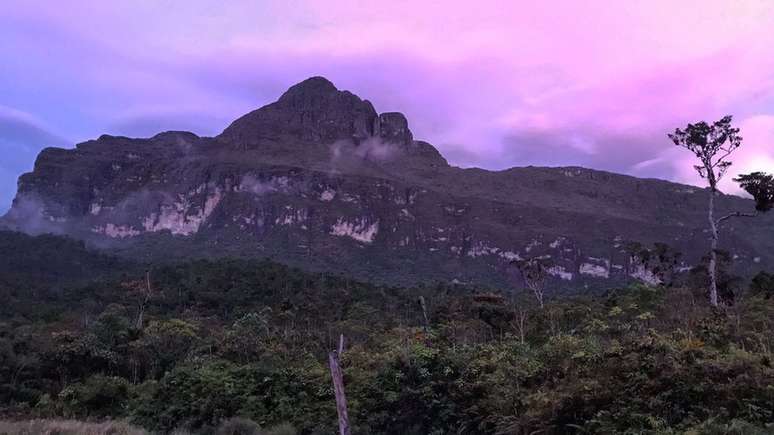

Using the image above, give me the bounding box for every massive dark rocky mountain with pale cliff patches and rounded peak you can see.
[3,77,774,291]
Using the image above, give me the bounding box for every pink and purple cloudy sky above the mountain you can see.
[0,0,774,206]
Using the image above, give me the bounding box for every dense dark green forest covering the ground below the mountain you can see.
[0,232,774,434]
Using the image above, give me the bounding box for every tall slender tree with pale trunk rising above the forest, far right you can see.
[668,116,772,306]
